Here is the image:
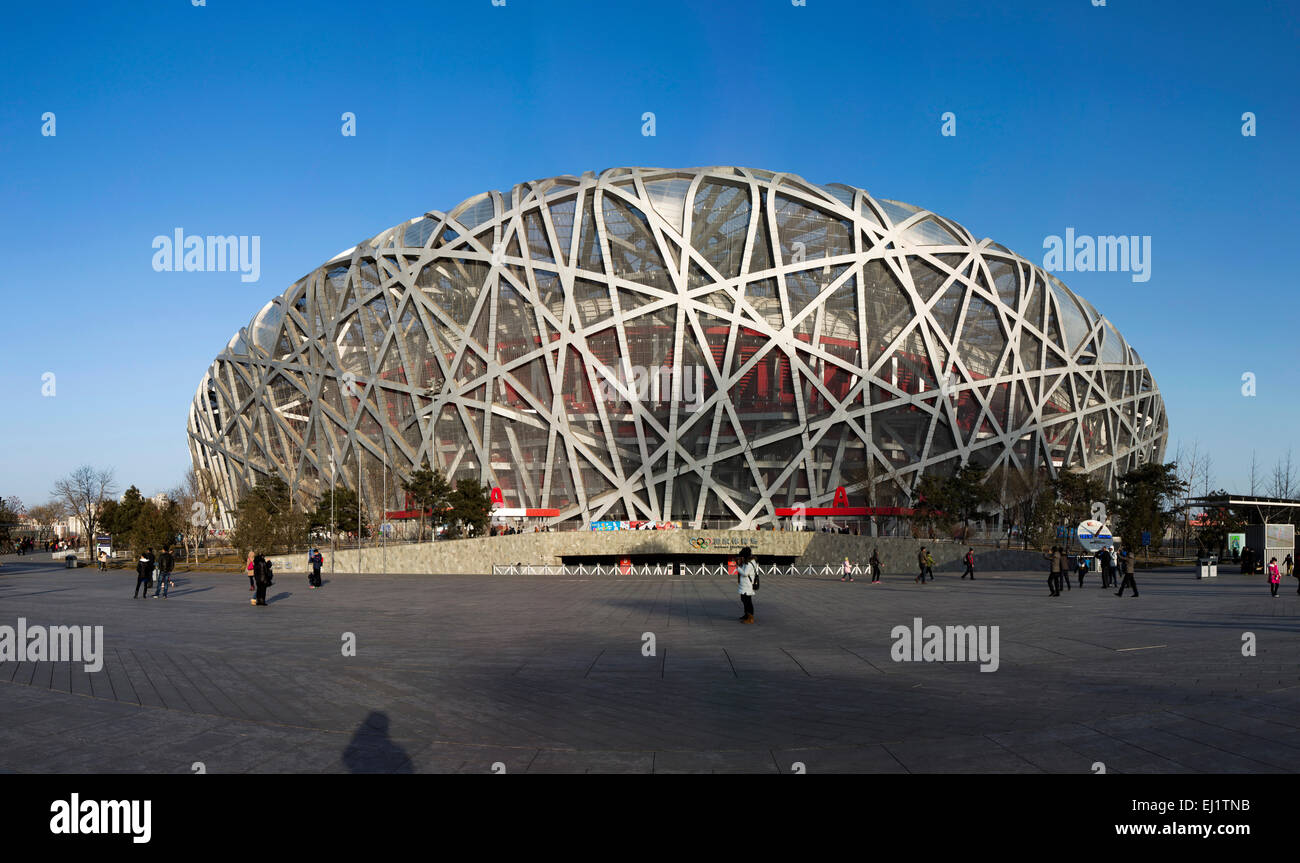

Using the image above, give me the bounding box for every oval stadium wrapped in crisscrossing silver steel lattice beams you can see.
[189,168,1169,526]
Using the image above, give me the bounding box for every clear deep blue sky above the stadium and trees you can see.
[0,0,1300,504]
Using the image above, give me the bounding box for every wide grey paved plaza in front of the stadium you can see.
[0,556,1300,773]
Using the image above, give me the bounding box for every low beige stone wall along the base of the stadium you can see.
[272,529,1045,574]
